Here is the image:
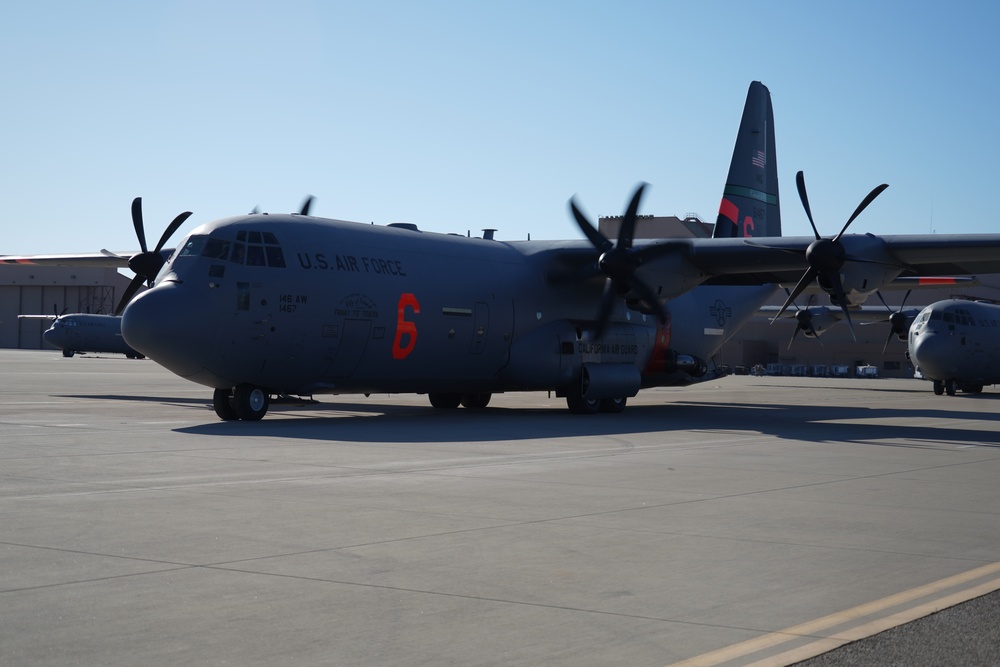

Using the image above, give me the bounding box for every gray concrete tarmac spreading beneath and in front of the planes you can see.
[0,350,1000,667]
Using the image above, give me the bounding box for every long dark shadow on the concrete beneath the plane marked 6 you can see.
[152,401,1000,448]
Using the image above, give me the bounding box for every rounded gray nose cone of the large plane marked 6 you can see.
[122,283,219,377]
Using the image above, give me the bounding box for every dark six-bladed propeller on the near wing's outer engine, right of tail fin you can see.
[771,171,889,341]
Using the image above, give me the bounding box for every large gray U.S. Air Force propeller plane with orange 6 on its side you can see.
[9,82,1000,421]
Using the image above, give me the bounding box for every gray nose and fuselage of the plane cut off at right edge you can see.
[908,299,1000,396]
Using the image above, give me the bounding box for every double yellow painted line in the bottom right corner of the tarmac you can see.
[669,562,1000,667]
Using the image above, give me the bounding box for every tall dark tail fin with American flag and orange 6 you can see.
[713,81,781,238]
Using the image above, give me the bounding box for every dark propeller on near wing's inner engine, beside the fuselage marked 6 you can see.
[569,183,667,338]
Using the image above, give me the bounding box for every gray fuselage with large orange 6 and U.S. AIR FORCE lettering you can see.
[123,215,728,410]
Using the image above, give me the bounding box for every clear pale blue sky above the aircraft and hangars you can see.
[0,0,1000,254]
